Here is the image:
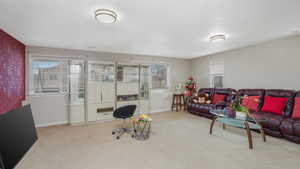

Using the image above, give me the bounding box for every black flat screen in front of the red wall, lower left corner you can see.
[0,105,37,169]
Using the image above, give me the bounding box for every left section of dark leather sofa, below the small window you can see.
[187,88,236,118]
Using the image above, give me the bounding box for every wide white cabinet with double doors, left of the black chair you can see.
[87,62,115,122]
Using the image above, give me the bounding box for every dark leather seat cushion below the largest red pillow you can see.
[252,112,283,131]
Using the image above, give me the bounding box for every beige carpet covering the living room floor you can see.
[17,112,300,169]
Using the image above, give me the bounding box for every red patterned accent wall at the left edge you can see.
[0,29,25,114]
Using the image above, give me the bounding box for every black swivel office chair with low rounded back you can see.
[112,105,136,139]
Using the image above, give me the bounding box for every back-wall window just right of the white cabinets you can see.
[151,64,168,89]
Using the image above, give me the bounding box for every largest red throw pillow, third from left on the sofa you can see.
[261,96,288,115]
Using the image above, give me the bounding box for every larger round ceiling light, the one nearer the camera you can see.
[95,9,118,23]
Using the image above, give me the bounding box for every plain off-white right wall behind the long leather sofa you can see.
[192,36,300,90]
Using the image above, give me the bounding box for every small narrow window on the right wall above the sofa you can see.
[209,58,224,88]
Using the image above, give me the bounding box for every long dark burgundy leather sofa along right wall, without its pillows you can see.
[187,88,300,144]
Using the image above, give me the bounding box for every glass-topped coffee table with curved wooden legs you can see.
[209,109,266,149]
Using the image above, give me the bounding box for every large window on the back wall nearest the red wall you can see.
[29,57,68,94]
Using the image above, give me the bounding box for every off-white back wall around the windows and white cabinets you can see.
[26,46,191,126]
